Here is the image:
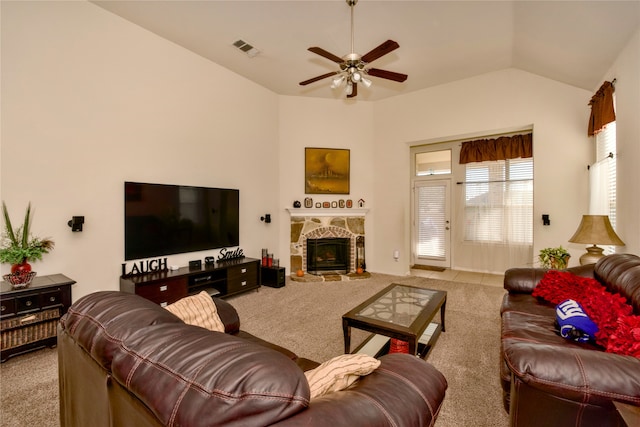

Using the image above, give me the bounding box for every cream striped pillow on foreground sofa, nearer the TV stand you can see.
[165,291,224,332]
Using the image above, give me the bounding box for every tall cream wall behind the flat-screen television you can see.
[0,2,282,300]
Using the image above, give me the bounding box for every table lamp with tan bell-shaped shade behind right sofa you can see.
[569,215,624,265]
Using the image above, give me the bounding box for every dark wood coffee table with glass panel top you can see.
[342,283,447,358]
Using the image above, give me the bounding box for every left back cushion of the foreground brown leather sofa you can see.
[60,291,183,371]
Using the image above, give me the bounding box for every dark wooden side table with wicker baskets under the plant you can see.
[0,274,76,362]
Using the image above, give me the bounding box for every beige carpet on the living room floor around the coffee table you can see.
[0,274,508,427]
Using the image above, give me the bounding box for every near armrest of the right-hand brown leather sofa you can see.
[503,340,640,406]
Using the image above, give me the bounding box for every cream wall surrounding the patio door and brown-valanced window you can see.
[372,69,591,274]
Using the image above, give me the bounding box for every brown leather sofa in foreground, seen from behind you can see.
[58,292,447,427]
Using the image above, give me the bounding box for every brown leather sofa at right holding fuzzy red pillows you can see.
[500,254,640,427]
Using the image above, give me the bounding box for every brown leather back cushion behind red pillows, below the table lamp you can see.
[594,254,640,314]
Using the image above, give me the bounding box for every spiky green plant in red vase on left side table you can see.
[0,201,54,286]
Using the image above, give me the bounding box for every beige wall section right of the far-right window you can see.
[594,29,640,254]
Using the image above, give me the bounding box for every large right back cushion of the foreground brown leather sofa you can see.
[112,324,310,427]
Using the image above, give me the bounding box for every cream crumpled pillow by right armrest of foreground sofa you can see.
[304,354,380,399]
